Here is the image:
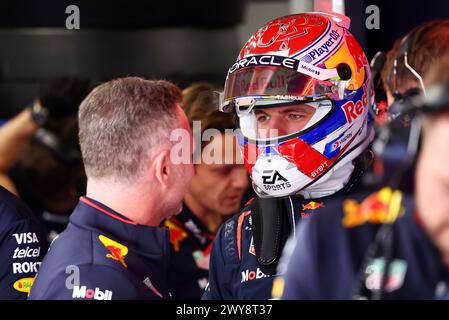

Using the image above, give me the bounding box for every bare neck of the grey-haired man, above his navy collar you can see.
[86,180,162,226]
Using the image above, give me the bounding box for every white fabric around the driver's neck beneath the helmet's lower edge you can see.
[297,161,354,199]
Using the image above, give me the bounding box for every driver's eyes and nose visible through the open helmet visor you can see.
[254,104,315,139]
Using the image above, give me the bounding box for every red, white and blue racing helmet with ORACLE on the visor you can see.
[220,13,374,197]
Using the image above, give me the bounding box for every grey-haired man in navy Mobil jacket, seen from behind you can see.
[30,77,194,300]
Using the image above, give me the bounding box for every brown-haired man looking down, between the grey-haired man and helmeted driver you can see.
[165,83,249,300]
